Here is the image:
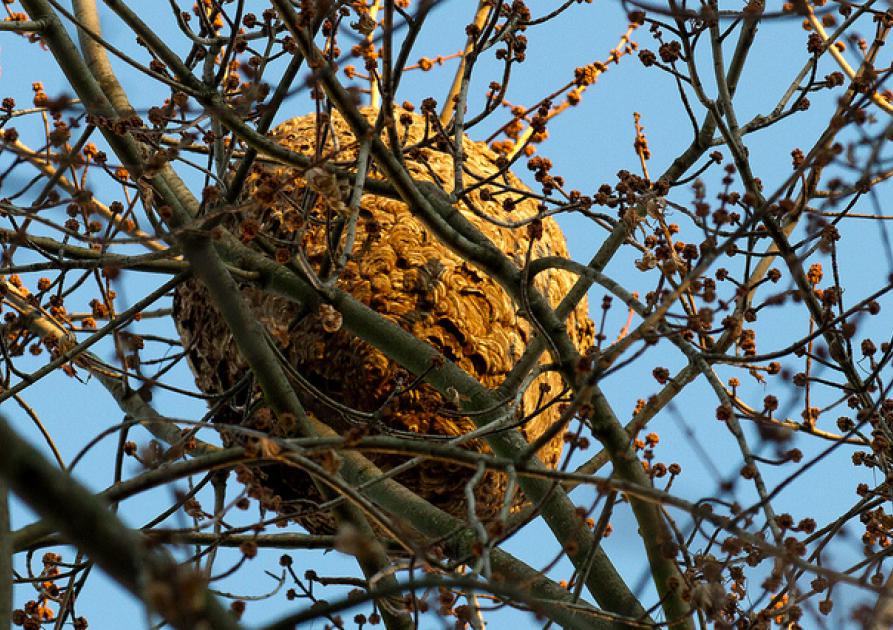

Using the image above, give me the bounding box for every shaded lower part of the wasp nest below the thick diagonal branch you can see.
[174,280,562,534]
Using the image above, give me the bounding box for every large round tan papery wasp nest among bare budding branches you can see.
[174,110,593,532]
